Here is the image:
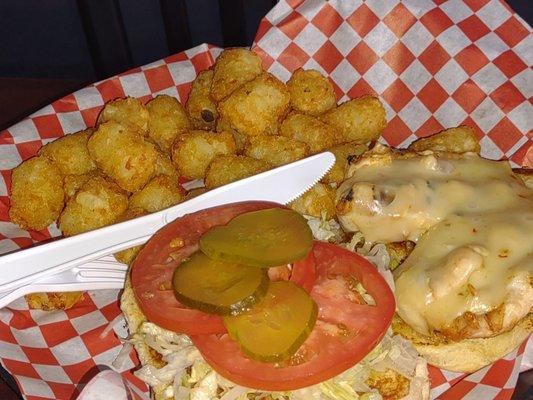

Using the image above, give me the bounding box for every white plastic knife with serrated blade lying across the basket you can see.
[0,152,335,291]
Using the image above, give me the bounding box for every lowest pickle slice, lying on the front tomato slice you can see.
[223,281,318,362]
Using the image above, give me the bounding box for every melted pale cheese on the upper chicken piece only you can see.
[337,154,533,243]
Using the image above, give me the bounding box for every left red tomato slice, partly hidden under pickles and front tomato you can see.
[131,201,315,335]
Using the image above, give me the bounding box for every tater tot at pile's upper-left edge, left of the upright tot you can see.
[97,97,150,136]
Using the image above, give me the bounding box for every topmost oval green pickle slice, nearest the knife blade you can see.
[200,208,313,268]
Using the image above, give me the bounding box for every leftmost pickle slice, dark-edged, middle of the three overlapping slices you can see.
[172,251,270,315]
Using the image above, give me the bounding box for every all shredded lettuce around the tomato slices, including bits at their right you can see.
[131,217,429,400]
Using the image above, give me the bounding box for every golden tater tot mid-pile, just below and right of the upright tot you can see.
[172,131,235,179]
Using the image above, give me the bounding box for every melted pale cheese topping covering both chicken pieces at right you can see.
[337,154,533,336]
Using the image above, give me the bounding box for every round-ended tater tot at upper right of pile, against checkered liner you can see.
[287,68,336,115]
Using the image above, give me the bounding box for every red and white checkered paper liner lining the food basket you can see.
[0,0,533,400]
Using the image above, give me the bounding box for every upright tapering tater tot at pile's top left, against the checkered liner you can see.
[146,94,191,154]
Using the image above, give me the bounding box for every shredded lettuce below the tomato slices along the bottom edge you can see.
[133,322,427,400]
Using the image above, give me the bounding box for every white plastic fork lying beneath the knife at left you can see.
[0,256,128,308]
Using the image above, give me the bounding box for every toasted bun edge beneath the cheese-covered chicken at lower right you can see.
[392,313,533,373]
